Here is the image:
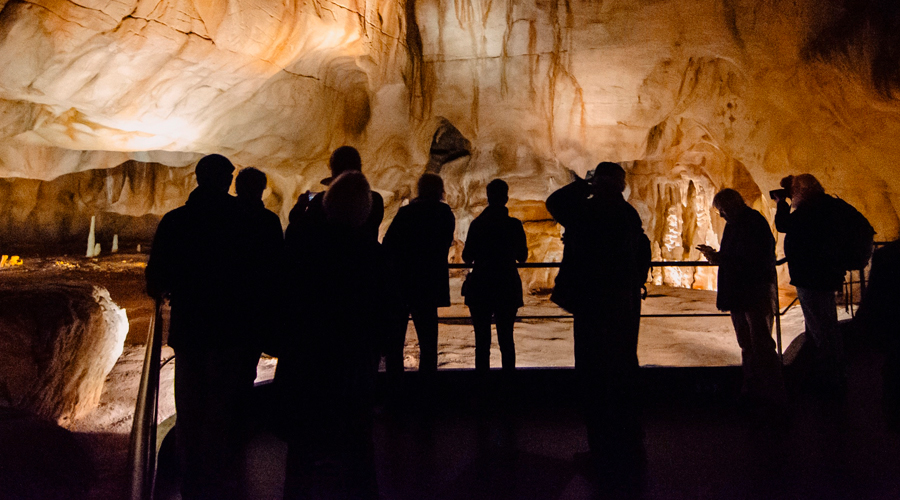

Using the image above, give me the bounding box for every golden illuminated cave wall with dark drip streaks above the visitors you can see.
[0,0,900,287]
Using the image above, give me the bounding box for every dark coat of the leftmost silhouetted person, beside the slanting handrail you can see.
[146,187,251,350]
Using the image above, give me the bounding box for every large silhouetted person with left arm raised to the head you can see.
[547,162,650,470]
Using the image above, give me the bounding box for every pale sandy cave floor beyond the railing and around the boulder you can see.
[0,253,852,498]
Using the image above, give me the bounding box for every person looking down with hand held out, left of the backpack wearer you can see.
[697,189,787,417]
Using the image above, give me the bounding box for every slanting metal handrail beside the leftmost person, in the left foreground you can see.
[128,299,169,500]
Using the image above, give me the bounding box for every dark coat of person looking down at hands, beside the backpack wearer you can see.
[716,207,775,311]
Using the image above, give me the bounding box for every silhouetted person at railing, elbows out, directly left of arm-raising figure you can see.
[462,179,528,372]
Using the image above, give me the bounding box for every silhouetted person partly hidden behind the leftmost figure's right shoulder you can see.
[234,167,284,351]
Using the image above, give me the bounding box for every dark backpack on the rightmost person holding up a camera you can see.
[832,197,875,271]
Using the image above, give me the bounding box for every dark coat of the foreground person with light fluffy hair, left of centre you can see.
[275,225,404,432]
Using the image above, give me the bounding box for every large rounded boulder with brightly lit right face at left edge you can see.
[0,280,128,425]
